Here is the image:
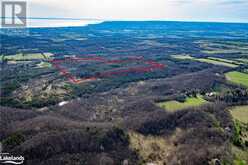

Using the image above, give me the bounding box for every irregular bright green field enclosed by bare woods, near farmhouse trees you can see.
[158,95,207,111]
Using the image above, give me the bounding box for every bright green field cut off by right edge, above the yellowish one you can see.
[225,71,248,87]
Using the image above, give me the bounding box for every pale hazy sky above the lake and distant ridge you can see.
[21,0,248,22]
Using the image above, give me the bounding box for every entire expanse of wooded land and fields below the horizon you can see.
[0,22,248,165]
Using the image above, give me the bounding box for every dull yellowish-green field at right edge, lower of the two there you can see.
[231,106,248,123]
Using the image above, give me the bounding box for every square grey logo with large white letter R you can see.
[1,1,27,28]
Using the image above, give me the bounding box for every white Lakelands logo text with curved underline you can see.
[0,153,25,164]
